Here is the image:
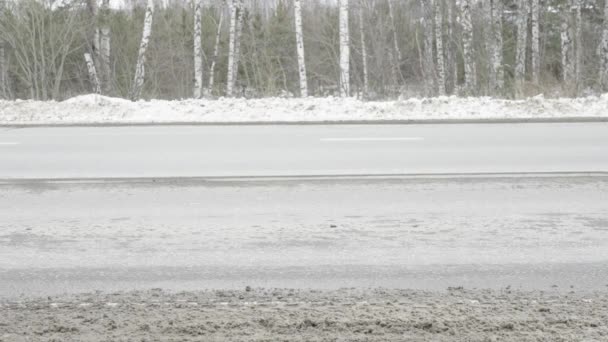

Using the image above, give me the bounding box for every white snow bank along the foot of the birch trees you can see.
[0,95,608,125]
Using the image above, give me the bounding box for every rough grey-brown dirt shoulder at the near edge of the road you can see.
[0,289,608,342]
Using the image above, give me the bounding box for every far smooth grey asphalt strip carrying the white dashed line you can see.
[0,123,608,179]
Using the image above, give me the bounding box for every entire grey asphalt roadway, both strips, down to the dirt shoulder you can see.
[0,123,608,297]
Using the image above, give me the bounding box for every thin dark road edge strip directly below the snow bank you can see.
[0,117,608,128]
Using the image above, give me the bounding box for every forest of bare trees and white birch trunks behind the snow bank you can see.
[0,0,608,100]
